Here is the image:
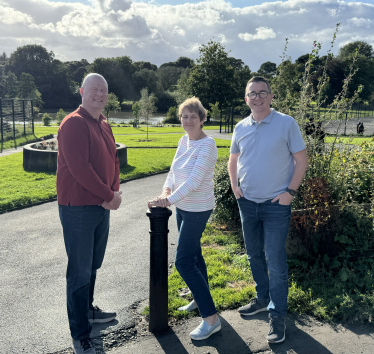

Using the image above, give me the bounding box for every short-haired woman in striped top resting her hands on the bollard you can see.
[148,97,221,340]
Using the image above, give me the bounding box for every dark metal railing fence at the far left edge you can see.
[0,98,34,147]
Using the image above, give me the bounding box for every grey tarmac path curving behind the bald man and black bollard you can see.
[0,174,177,354]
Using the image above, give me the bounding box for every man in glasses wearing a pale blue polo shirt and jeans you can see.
[228,77,308,343]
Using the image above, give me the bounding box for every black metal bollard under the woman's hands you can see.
[147,207,172,332]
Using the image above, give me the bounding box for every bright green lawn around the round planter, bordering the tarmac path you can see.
[0,148,229,212]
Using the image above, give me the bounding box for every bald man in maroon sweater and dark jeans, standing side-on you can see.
[57,74,122,354]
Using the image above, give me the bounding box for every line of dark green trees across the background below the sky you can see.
[0,40,374,116]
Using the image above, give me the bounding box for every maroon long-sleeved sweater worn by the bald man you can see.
[57,107,119,206]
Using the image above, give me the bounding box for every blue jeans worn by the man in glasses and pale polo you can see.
[238,197,291,317]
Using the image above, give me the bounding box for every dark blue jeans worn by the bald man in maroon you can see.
[58,205,110,340]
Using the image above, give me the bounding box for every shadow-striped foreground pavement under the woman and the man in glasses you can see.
[106,310,374,354]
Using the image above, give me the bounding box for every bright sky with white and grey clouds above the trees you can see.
[0,0,374,71]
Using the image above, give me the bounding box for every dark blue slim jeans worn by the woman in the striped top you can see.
[175,208,217,318]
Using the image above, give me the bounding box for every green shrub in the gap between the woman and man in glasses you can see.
[213,158,240,227]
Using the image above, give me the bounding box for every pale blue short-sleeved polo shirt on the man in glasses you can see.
[230,109,305,203]
